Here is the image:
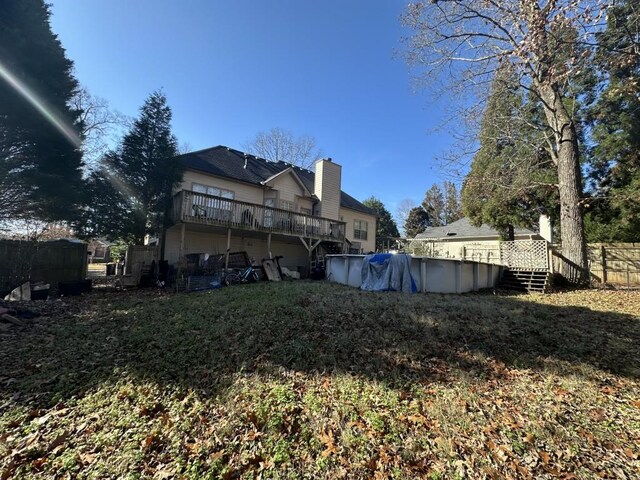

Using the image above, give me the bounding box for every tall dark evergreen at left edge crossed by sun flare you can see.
[0,0,83,225]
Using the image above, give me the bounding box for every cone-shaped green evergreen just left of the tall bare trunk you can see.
[462,68,557,237]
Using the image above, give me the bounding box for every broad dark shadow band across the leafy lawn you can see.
[0,282,640,406]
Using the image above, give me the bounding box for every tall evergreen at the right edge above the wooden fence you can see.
[586,0,640,242]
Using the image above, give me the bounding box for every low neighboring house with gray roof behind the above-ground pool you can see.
[410,218,544,261]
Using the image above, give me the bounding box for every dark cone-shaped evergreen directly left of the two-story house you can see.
[84,92,183,243]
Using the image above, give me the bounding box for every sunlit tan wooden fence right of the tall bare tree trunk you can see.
[553,243,640,287]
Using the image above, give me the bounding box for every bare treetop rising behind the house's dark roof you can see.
[244,127,322,168]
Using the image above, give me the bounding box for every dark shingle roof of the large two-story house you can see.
[179,145,376,215]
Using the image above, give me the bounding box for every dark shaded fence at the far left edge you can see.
[0,240,87,293]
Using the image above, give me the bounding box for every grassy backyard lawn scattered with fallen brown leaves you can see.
[0,282,640,480]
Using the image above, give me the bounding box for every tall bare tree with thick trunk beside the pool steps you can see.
[403,0,610,281]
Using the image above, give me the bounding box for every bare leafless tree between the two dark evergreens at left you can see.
[71,87,131,169]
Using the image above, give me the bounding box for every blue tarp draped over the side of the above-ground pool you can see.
[360,253,418,293]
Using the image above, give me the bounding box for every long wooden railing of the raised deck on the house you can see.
[172,190,346,242]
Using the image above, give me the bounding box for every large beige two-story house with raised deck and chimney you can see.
[164,146,376,271]
